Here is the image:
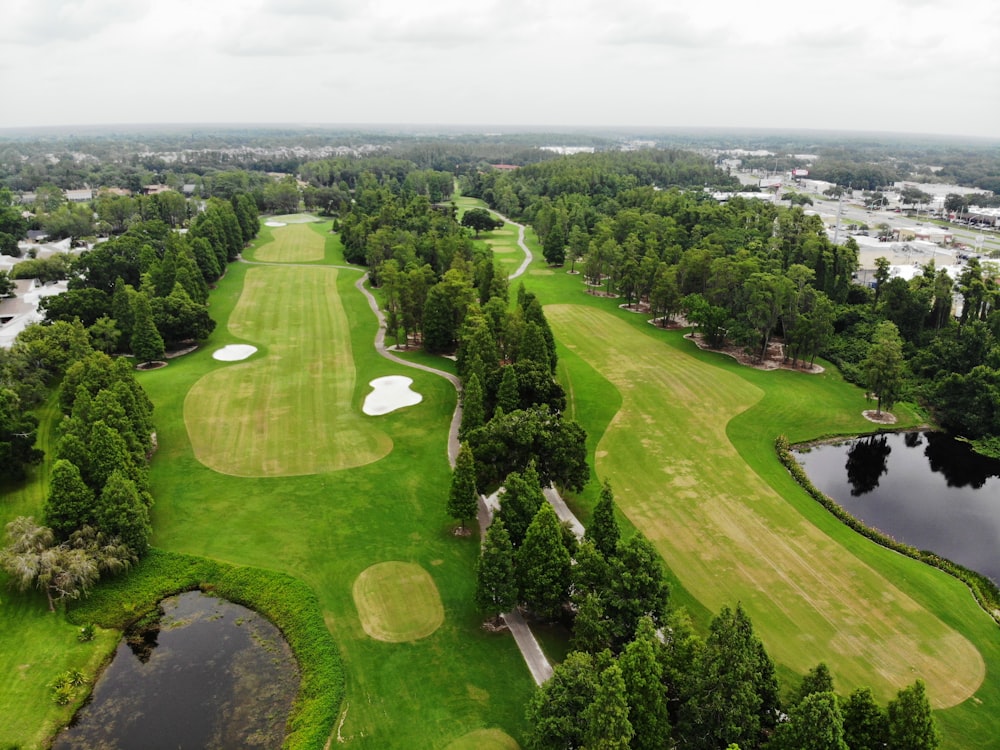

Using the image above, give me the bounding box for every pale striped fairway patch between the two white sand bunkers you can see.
[184,266,392,477]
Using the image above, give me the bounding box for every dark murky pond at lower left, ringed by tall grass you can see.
[52,591,299,750]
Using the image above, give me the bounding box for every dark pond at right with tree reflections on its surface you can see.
[796,432,1000,581]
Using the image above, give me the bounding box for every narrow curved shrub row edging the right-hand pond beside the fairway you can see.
[774,435,1000,623]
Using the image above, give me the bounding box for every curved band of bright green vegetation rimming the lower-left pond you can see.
[67,549,344,750]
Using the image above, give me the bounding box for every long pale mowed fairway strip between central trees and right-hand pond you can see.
[545,305,985,707]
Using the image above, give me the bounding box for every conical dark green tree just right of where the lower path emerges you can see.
[515,503,570,619]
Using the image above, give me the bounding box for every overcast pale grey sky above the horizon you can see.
[0,0,1000,137]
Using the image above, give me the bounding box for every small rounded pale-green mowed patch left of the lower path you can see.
[353,561,444,643]
